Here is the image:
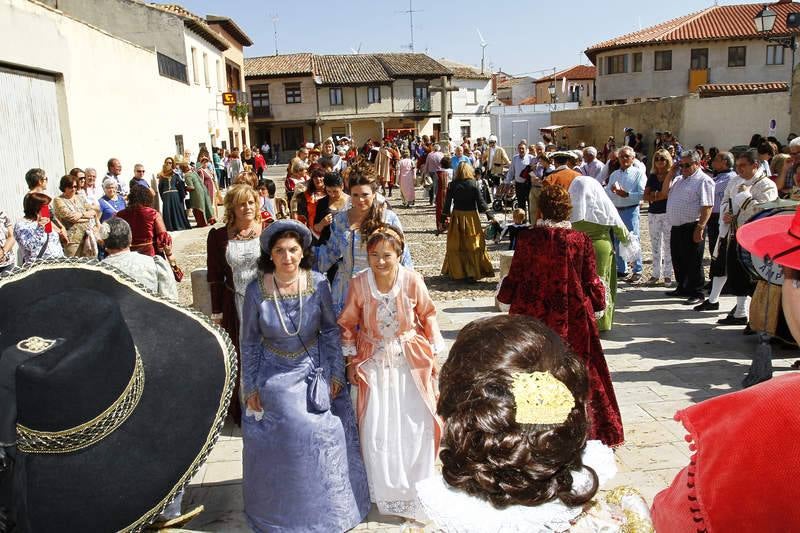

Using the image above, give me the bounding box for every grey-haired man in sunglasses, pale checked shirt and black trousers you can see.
[666,151,714,305]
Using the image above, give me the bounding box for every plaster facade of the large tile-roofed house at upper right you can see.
[596,40,791,102]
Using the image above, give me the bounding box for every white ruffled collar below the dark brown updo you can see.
[416,440,617,533]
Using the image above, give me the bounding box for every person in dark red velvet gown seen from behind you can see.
[497,185,624,446]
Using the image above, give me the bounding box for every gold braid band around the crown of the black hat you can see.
[17,350,144,453]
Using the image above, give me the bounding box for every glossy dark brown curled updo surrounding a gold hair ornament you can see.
[437,315,598,509]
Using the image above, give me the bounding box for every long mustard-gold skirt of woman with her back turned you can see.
[442,210,494,279]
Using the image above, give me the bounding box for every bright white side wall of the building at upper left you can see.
[0,0,224,187]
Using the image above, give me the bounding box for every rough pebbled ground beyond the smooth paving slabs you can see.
[172,166,709,303]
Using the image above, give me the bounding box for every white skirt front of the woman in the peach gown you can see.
[360,354,435,520]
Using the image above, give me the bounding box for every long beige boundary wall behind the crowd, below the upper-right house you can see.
[551,93,790,151]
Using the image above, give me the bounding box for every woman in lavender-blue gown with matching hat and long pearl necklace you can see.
[241,220,370,533]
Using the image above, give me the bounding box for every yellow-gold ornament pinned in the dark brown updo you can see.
[511,372,575,424]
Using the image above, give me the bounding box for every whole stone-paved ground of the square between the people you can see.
[175,168,798,532]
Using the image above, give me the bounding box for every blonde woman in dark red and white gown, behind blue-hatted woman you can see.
[206,185,261,424]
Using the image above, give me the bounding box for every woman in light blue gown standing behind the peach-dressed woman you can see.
[315,164,414,317]
